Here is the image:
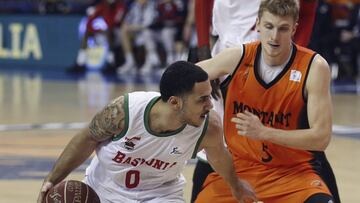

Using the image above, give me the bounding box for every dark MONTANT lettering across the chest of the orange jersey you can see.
[233,101,291,127]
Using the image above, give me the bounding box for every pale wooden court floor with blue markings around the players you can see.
[0,73,360,203]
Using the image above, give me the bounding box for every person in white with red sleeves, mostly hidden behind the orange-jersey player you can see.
[191,0,340,202]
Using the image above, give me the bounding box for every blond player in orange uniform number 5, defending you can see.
[196,0,333,203]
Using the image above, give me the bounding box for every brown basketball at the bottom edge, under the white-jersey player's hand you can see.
[43,180,100,203]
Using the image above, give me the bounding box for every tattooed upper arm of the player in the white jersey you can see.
[89,96,125,141]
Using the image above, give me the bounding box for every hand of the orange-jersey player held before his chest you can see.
[231,111,265,140]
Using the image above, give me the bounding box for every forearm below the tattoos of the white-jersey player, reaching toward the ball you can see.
[46,131,98,185]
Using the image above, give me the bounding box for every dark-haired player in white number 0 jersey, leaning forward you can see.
[38,62,256,203]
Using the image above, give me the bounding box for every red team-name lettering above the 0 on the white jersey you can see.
[112,151,177,170]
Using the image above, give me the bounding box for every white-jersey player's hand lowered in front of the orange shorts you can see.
[231,179,258,203]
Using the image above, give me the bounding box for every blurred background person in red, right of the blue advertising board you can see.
[67,0,126,73]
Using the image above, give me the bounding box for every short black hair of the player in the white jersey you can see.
[160,61,209,102]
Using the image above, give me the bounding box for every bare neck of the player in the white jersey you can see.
[149,100,184,133]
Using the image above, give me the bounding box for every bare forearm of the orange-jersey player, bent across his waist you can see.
[261,127,331,151]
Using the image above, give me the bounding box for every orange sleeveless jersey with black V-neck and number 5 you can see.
[224,42,315,166]
